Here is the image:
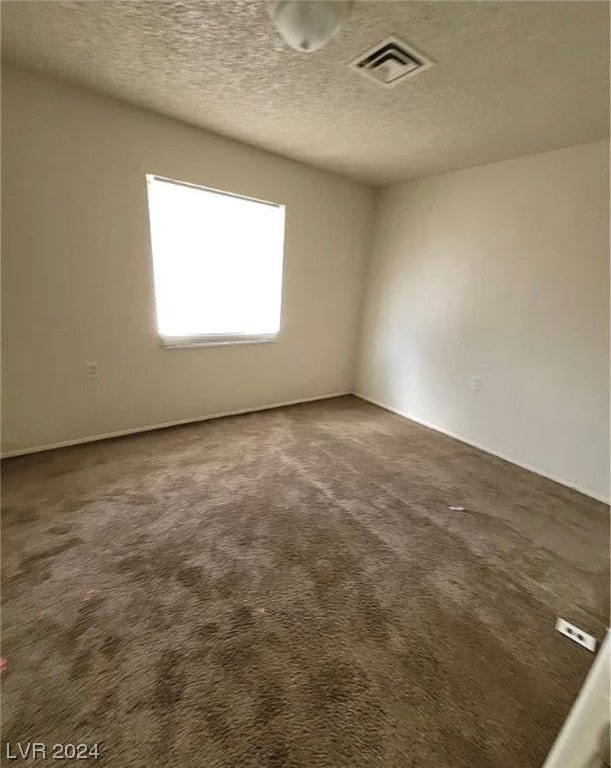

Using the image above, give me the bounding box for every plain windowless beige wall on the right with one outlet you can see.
[357,142,609,498]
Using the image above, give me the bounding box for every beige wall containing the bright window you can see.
[2,66,373,452]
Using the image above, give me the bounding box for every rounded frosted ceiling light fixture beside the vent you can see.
[271,0,349,53]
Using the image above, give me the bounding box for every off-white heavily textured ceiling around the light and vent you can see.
[1,0,609,184]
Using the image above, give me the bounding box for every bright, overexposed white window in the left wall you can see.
[146,175,284,346]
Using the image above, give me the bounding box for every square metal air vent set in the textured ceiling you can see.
[350,37,434,87]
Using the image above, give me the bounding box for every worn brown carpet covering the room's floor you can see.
[2,397,609,768]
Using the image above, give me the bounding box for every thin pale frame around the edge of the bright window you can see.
[145,173,286,349]
